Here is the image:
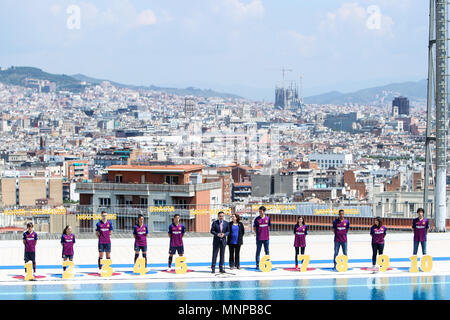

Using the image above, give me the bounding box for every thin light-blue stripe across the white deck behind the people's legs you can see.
[0,257,450,270]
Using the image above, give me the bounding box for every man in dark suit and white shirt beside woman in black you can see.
[211,211,230,273]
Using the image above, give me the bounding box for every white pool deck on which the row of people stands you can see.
[0,233,450,285]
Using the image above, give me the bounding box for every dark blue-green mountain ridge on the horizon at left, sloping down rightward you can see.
[0,66,242,99]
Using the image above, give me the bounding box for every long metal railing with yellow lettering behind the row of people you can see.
[0,202,450,237]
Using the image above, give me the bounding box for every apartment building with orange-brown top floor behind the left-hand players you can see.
[76,165,223,232]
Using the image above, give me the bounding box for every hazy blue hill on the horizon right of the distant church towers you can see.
[304,80,427,105]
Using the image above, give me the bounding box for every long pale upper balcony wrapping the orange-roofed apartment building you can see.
[75,181,222,197]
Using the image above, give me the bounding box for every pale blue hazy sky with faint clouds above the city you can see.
[0,0,429,99]
